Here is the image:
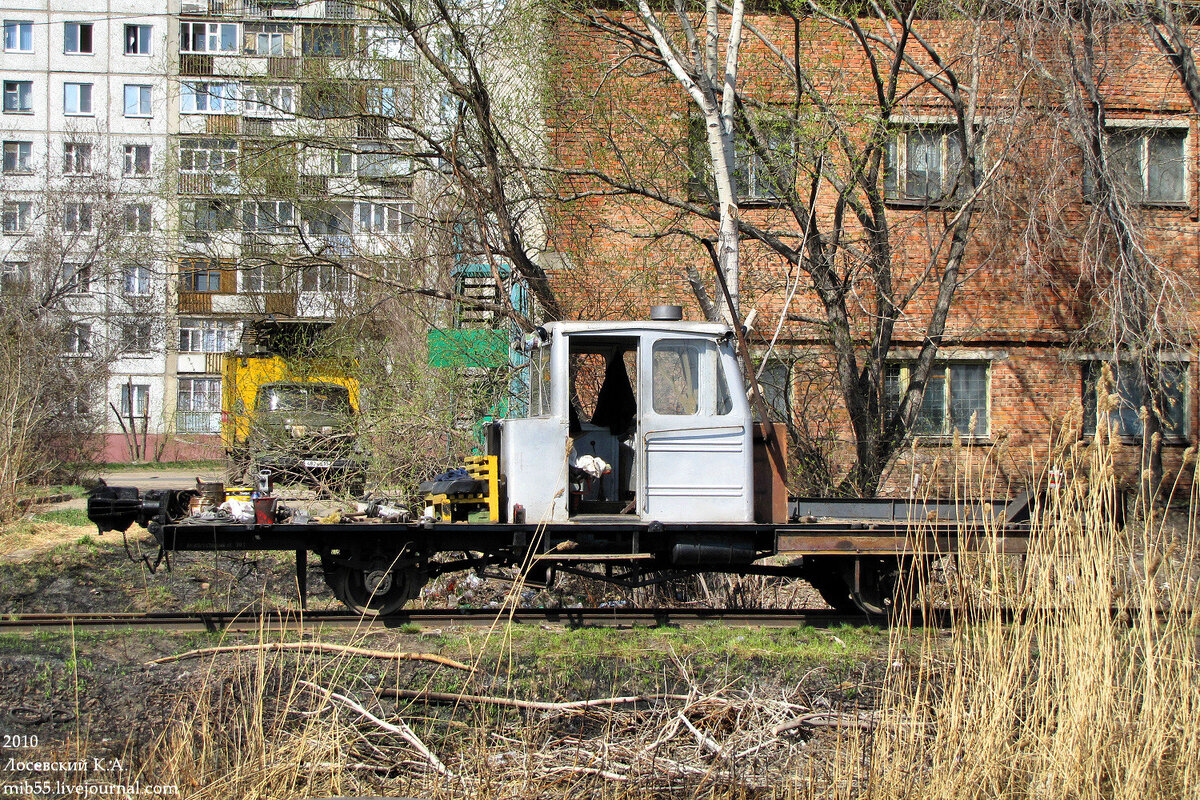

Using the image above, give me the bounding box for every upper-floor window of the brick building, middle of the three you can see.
[883,125,967,203]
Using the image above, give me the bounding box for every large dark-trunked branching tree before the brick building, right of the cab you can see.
[560,2,1013,494]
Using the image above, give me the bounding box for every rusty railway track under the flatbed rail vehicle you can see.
[0,608,892,633]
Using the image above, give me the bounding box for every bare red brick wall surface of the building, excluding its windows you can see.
[548,12,1200,493]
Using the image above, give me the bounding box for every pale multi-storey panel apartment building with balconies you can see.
[0,0,418,461]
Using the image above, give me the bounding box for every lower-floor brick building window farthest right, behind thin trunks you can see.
[1082,361,1188,440]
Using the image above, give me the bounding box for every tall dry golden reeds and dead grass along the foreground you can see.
[124,431,1200,800]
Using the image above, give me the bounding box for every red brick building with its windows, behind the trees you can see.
[548,10,1200,494]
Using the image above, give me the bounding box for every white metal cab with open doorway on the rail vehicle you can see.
[498,321,755,523]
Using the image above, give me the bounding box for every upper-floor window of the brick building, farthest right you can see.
[1084,127,1188,205]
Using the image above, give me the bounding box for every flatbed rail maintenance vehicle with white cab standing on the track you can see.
[88,307,1030,615]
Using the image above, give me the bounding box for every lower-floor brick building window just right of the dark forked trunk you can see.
[884,361,990,437]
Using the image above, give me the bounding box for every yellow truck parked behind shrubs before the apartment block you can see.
[221,353,366,493]
